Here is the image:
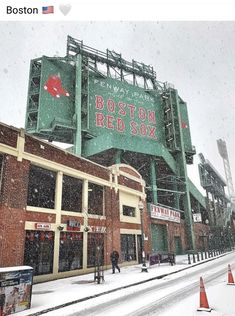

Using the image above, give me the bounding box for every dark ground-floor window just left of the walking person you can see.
[87,233,104,268]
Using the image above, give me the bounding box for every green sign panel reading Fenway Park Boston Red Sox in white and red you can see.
[89,75,164,141]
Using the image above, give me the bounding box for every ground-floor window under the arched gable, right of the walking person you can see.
[121,234,136,261]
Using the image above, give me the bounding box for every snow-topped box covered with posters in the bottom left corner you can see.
[0,266,33,316]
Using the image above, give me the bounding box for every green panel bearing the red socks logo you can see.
[38,57,75,131]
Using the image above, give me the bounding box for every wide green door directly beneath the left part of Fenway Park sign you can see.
[151,224,168,253]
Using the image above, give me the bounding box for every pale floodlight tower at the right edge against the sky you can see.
[217,139,235,203]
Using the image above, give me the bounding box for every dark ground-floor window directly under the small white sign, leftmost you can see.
[24,230,54,275]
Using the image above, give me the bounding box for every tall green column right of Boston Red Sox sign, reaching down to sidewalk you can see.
[174,90,195,250]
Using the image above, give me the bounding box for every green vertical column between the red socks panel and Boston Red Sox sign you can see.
[74,55,82,156]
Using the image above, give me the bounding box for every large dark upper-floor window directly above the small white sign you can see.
[27,165,56,209]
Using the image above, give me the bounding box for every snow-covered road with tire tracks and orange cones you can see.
[46,253,235,316]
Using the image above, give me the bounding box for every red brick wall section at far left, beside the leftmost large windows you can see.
[0,155,29,267]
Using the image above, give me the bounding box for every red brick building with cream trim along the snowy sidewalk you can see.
[0,124,209,282]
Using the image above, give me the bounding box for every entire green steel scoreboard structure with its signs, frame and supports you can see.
[25,37,205,249]
